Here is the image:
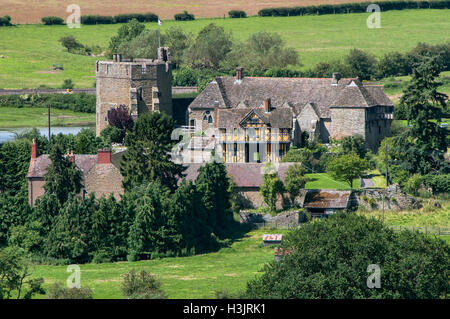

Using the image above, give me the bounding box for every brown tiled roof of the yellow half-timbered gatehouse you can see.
[217,107,293,128]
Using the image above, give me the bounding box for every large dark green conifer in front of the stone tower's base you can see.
[120,112,185,191]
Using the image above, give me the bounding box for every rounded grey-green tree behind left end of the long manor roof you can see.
[186,23,232,69]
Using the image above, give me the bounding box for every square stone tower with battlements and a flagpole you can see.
[96,48,173,136]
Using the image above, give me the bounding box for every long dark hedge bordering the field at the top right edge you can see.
[258,0,450,17]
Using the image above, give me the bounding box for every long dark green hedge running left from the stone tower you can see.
[0,93,96,113]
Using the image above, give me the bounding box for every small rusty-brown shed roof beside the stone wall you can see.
[303,189,351,209]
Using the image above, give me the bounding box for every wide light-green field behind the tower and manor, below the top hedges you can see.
[0,10,450,89]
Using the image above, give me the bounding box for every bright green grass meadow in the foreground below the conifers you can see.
[33,230,287,299]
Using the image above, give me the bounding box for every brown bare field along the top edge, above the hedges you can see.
[0,0,372,23]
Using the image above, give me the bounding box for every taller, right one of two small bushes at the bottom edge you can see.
[121,269,165,299]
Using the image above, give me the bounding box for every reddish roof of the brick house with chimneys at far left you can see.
[27,154,97,178]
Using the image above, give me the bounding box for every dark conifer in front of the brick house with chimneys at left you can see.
[44,144,82,205]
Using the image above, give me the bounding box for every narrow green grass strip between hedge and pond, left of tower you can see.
[0,107,95,128]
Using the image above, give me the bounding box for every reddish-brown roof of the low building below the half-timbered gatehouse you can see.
[184,163,294,187]
